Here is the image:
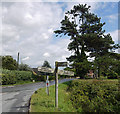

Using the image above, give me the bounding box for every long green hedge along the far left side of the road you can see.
[0,69,70,85]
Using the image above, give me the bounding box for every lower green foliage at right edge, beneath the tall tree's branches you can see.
[94,52,120,76]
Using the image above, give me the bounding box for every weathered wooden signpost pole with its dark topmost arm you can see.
[55,61,67,108]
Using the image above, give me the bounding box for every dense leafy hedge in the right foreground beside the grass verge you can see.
[68,80,120,112]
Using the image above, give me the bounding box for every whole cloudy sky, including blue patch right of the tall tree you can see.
[1,2,118,67]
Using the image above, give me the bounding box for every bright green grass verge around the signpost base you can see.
[30,82,76,112]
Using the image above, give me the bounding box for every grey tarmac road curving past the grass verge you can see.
[0,78,75,113]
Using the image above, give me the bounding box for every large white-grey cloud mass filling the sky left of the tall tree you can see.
[2,2,68,67]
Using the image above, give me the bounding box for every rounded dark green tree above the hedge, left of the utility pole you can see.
[1,56,17,70]
